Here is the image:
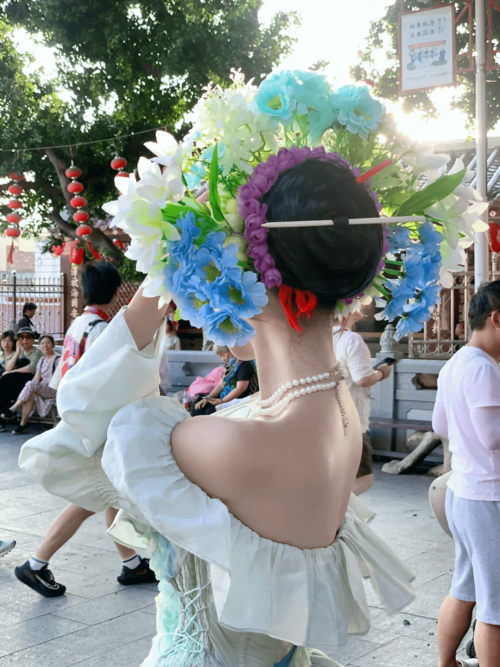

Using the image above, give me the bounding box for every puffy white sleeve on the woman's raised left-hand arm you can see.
[19,311,164,512]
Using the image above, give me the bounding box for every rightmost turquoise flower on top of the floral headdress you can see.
[335,86,384,139]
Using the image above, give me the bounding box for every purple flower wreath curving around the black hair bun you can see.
[237,146,382,289]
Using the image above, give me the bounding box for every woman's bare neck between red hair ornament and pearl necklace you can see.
[252,314,337,399]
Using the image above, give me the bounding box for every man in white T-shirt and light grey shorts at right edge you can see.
[432,280,500,667]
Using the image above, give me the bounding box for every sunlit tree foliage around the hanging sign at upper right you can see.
[351,0,500,129]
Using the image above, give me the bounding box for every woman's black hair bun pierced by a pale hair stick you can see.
[263,158,383,308]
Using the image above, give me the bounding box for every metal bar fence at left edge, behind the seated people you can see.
[0,271,64,338]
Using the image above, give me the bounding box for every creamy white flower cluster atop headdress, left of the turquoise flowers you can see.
[188,70,280,175]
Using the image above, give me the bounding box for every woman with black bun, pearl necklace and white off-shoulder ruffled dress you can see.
[20,159,414,667]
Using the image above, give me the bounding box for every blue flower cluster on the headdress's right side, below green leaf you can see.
[384,222,443,340]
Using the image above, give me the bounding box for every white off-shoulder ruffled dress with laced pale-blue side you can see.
[19,313,414,667]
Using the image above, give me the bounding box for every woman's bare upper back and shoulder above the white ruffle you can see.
[172,383,361,549]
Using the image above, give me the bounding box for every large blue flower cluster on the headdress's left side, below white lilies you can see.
[164,212,268,347]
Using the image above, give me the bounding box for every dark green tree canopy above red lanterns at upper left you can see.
[0,0,298,266]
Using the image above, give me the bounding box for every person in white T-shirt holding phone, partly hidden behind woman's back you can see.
[333,311,394,496]
